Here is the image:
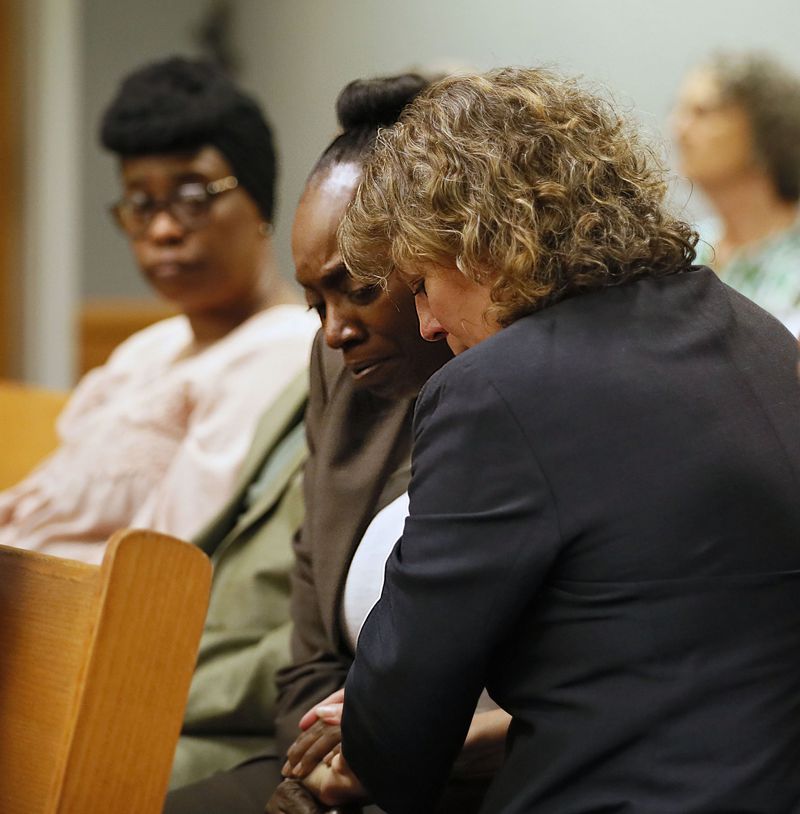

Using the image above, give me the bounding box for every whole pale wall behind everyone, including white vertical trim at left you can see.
[18,0,800,386]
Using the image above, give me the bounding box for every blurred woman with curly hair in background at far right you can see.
[673,54,800,334]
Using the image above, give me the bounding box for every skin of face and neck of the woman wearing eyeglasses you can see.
[121,146,296,348]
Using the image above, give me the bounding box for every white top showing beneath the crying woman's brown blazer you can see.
[342,492,408,652]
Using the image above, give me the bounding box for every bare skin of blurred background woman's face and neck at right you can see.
[672,68,798,273]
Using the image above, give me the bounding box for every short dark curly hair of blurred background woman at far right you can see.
[708,53,800,202]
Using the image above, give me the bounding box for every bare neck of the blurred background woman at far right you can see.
[705,171,798,253]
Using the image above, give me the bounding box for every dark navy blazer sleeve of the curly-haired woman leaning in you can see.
[342,357,560,813]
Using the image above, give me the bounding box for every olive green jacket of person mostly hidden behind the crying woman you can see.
[170,371,308,788]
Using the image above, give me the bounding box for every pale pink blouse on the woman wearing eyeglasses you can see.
[0,305,319,563]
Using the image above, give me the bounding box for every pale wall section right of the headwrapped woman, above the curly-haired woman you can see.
[234,0,800,280]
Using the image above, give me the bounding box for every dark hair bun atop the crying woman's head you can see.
[336,73,429,132]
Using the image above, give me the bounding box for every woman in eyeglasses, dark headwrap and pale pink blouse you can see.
[0,58,319,562]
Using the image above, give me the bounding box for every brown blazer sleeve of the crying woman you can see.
[275,332,350,755]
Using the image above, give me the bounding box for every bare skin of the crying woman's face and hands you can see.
[266,162,451,814]
